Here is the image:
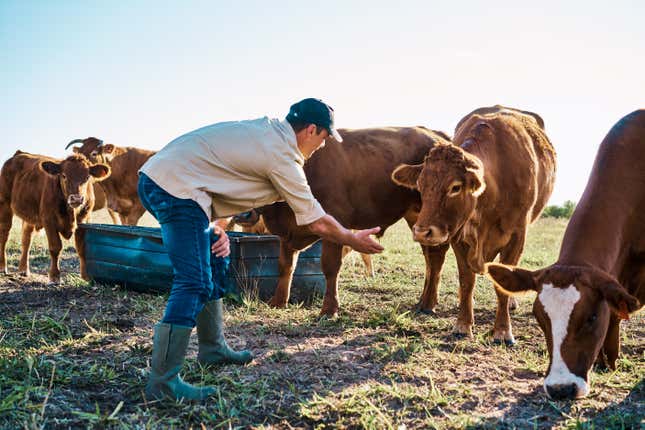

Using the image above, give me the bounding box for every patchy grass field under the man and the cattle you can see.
[0,212,645,429]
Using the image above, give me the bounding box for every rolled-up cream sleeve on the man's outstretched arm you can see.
[269,161,325,225]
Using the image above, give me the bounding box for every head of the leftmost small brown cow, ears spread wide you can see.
[40,155,110,209]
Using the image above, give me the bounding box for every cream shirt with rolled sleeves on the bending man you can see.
[139,117,325,225]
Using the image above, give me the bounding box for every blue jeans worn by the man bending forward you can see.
[138,173,229,327]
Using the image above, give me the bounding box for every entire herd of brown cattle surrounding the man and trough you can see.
[0,105,645,398]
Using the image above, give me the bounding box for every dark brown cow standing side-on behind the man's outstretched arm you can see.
[255,127,450,316]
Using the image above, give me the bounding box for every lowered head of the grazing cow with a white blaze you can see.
[486,263,640,399]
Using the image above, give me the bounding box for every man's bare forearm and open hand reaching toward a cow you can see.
[307,214,383,254]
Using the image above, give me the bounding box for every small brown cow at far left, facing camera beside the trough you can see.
[0,151,110,282]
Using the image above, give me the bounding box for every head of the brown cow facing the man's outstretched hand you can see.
[392,144,486,246]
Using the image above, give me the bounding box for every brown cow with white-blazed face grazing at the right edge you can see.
[487,110,645,398]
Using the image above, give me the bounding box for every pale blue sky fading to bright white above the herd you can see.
[0,0,645,203]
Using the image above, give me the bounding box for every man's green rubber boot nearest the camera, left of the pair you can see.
[146,323,215,401]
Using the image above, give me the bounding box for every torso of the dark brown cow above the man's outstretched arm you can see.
[305,127,449,229]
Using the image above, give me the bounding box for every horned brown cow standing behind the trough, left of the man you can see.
[65,137,155,225]
